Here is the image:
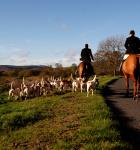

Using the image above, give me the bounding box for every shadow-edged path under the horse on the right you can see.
[104,78,140,150]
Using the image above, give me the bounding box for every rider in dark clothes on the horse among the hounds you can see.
[80,44,95,76]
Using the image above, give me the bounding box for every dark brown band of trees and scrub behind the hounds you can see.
[0,65,77,79]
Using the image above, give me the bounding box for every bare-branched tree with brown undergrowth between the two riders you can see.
[94,37,125,75]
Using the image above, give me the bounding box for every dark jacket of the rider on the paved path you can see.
[124,36,140,54]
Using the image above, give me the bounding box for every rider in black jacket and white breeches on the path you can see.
[120,30,140,71]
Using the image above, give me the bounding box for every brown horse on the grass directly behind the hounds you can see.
[78,61,91,81]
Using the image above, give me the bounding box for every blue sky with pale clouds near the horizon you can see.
[0,0,140,66]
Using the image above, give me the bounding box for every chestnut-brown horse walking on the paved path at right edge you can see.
[122,54,140,100]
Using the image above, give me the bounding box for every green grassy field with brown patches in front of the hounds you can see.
[0,76,131,150]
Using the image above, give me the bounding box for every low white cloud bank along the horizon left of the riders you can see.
[0,48,79,67]
